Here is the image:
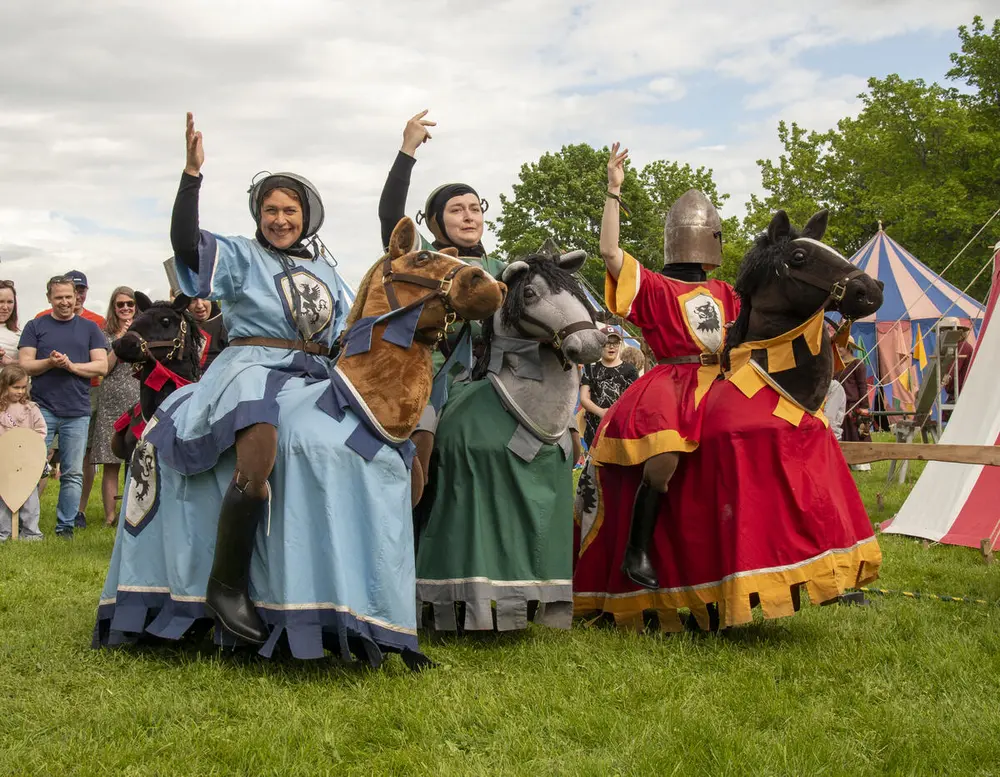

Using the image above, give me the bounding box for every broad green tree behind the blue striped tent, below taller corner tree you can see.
[744,66,1000,298]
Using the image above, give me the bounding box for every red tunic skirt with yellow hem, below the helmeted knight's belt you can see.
[591,364,719,465]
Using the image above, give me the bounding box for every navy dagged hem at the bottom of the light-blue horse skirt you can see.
[91,591,423,667]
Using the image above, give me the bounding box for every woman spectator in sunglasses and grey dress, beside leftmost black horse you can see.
[88,286,139,526]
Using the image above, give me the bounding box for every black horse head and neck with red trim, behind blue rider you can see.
[111,291,204,461]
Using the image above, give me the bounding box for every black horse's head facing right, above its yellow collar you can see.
[726,210,882,350]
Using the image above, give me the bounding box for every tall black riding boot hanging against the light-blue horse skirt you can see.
[205,482,268,644]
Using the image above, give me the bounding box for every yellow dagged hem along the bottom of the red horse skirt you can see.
[573,537,882,631]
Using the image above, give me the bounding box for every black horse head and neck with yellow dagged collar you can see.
[726,210,882,411]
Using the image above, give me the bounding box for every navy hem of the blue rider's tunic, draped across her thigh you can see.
[146,369,292,475]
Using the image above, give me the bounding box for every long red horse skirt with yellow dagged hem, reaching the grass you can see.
[573,372,881,630]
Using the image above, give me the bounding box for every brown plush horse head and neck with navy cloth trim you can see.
[337,218,506,438]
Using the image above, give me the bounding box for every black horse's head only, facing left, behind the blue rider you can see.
[113,291,202,381]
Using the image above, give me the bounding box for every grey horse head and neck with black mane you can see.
[473,251,606,438]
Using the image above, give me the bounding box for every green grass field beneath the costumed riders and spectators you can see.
[0,452,1000,777]
